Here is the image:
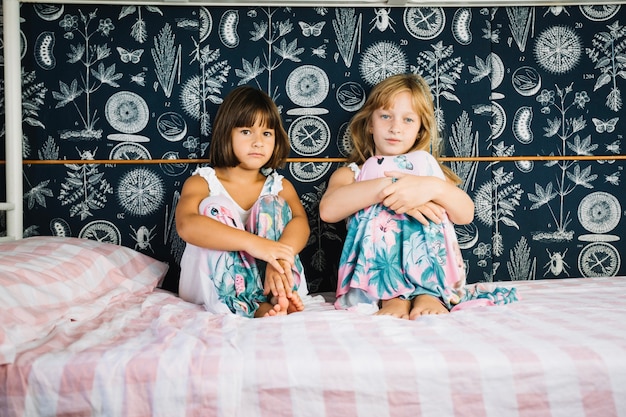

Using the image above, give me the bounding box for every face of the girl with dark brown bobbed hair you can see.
[232,118,276,170]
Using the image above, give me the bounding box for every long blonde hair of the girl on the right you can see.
[348,74,461,185]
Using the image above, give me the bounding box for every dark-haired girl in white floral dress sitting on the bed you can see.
[176,86,309,317]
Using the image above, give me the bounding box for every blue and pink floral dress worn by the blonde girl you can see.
[335,151,516,309]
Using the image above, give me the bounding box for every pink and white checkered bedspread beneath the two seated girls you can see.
[0,278,626,417]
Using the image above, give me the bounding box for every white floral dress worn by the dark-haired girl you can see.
[179,167,307,317]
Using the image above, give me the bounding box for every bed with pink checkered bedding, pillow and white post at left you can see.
[0,0,626,417]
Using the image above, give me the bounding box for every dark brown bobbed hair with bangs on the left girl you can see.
[209,86,290,169]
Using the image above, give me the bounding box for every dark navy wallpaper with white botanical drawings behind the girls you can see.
[2,3,626,291]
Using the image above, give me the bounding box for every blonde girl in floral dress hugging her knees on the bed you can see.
[320,74,516,319]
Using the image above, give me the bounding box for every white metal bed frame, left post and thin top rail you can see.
[0,0,626,241]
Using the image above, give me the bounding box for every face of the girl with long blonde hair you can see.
[370,91,422,156]
